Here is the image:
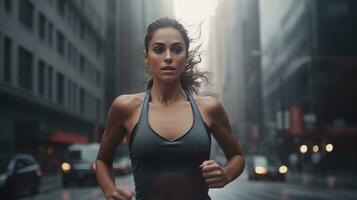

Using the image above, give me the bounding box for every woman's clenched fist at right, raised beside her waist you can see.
[200,160,230,188]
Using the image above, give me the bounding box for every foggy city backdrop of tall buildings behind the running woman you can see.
[0,0,357,200]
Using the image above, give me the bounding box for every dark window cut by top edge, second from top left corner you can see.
[19,0,34,30]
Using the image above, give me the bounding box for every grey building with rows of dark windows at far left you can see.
[0,0,105,170]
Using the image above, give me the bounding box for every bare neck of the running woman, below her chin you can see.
[151,83,187,105]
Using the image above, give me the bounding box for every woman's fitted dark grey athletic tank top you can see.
[129,90,211,200]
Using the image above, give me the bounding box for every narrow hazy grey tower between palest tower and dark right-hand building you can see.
[240,0,265,153]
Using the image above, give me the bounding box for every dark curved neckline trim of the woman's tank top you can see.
[144,90,196,143]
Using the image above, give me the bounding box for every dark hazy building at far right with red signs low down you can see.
[261,0,357,171]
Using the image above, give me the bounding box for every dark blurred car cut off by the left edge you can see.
[0,154,42,199]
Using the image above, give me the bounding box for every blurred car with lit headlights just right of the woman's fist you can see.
[246,155,288,181]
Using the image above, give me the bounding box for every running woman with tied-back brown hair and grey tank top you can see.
[96,18,244,200]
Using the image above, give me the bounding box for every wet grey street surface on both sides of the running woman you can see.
[21,171,357,200]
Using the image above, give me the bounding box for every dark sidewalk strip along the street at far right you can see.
[287,173,357,189]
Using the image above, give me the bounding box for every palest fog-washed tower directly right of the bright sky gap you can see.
[208,0,244,138]
